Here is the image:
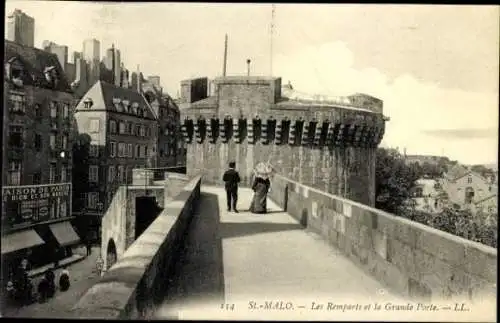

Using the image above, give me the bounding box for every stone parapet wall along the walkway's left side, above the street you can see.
[71,176,201,319]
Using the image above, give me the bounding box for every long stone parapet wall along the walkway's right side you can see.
[270,175,497,304]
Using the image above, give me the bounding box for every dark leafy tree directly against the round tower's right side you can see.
[375,148,419,215]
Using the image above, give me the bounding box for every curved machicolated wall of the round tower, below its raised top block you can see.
[185,109,384,205]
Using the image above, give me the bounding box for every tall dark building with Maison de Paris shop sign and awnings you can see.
[2,40,79,278]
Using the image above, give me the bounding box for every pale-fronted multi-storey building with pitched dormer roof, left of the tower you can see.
[74,81,158,235]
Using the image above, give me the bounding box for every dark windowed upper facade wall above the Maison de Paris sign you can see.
[2,83,74,185]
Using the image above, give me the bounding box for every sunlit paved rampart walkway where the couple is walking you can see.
[156,186,401,320]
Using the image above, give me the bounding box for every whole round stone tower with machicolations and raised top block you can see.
[180,76,385,205]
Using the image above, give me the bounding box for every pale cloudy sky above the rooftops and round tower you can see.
[6,0,500,164]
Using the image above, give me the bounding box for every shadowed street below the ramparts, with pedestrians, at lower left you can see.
[3,246,99,318]
